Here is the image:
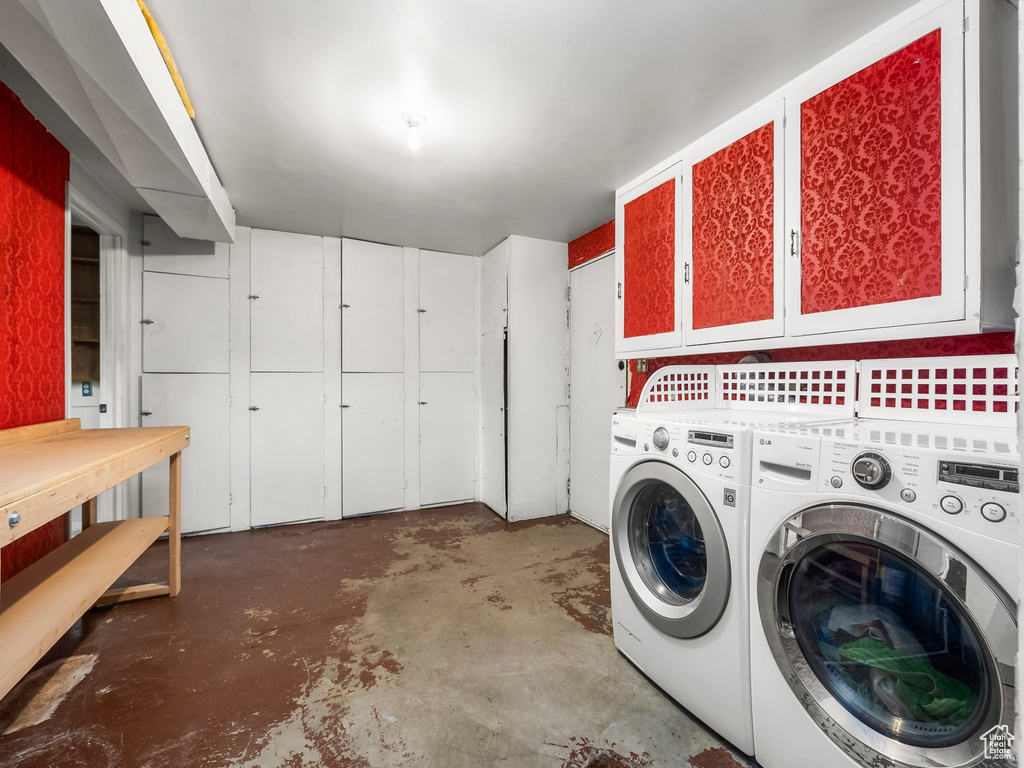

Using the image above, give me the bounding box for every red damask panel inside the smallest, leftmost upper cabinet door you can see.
[623,178,676,339]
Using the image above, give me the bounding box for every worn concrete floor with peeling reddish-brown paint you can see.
[0,504,749,768]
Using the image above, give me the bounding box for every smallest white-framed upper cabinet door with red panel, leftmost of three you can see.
[615,163,682,356]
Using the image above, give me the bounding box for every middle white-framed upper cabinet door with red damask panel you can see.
[680,101,785,346]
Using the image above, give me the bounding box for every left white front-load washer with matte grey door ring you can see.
[609,365,853,755]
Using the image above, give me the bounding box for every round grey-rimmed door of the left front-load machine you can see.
[611,462,730,638]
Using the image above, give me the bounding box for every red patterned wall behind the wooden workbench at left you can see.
[0,83,69,581]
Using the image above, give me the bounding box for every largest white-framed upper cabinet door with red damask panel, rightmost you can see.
[786,3,965,336]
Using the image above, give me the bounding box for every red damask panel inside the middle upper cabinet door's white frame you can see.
[692,123,775,329]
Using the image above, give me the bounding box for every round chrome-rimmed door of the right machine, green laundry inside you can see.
[758,505,1017,766]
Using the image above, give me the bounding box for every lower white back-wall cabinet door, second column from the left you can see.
[249,374,324,526]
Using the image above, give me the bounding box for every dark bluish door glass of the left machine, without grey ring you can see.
[630,483,708,605]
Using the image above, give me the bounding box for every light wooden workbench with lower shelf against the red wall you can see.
[0,419,189,697]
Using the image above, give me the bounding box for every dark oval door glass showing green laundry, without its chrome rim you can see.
[788,543,992,748]
